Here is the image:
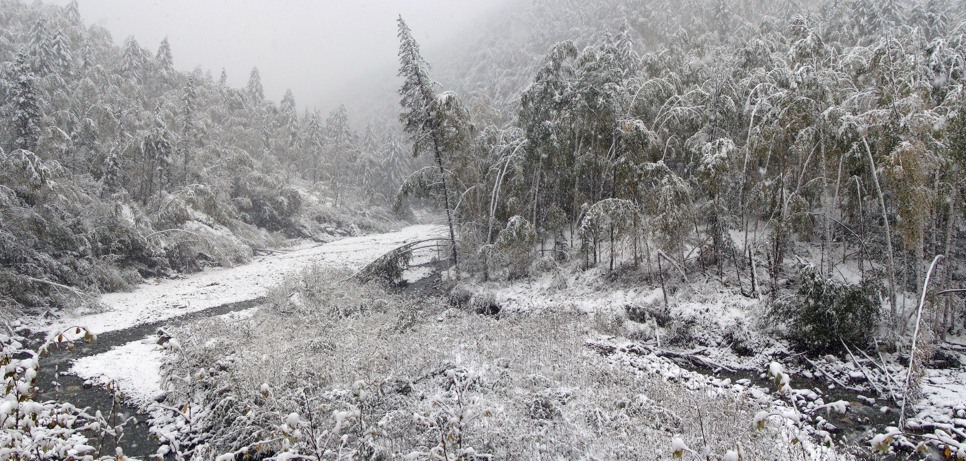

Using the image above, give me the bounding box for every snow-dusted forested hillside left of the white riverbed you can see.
[0,0,411,310]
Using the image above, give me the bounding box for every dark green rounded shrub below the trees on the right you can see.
[775,268,880,353]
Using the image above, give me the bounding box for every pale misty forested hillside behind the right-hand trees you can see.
[432,0,948,120]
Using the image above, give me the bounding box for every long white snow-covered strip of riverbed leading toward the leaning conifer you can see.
[28,225,445,335]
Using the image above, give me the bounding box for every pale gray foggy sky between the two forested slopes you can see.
[52,0,502,112]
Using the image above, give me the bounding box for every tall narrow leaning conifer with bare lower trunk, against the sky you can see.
[397,16,460,278]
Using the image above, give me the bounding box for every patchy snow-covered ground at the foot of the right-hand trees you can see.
[470,265,966,454]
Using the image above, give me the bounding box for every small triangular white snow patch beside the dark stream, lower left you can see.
[70,336,164,408]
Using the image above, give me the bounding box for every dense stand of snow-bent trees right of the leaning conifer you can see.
[410,0,966,330]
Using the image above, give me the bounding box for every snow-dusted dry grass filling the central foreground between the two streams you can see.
[161,271,840,459]
